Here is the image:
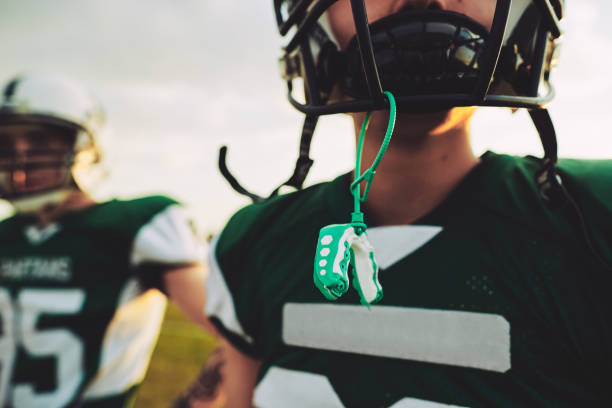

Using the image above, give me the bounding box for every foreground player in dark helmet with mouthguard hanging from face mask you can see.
[198,0,612,408]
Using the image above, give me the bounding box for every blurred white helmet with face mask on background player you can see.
[0,75,104,212]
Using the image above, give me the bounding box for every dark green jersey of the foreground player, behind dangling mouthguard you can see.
[207,153,612,408]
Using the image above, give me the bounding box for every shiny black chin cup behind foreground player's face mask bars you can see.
[338,10,489,102]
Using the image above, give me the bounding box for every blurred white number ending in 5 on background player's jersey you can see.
[0,288,85,408]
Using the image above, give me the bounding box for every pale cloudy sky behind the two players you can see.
[0,0,612,232]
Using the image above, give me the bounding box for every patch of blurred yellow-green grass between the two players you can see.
[136,303,215,408]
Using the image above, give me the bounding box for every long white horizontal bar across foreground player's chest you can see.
[283,303,511,373]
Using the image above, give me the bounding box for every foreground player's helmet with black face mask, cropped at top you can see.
[275,0,562,115]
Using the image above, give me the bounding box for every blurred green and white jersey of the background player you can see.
[0,196,199,408]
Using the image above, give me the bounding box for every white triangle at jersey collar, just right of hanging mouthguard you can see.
[368,225,442,269]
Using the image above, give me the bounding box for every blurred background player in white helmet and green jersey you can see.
[0,75,214,408]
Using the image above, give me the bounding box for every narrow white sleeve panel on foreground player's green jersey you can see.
[205,236,253,343]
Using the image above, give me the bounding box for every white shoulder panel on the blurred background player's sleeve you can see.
[130,204,205,266]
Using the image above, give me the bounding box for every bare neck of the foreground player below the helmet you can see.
[355,110,479,225]
